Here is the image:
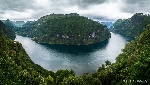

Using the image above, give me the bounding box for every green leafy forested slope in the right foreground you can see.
[93,24,150,85]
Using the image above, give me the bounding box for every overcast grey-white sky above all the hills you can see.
[0,0,150,21]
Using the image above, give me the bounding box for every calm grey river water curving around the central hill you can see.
[16,33,130,75]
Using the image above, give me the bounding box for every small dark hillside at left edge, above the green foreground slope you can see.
[0,20,16,40]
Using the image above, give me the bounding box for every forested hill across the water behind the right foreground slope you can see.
[110,13,150,37]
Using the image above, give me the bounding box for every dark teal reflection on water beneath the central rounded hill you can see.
[41,40,108,54]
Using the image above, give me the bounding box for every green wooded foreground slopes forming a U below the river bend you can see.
[0,16,150,85]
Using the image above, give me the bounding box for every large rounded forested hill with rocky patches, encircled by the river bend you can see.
[18,13,111,45]
